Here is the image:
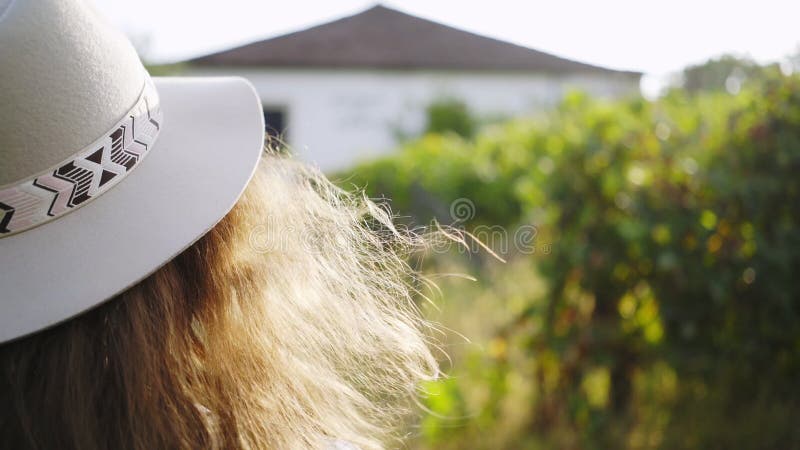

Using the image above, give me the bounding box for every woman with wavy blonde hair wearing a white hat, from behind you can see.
[0,0,436,449]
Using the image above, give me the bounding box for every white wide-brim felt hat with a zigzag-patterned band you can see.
[0,0,264,343]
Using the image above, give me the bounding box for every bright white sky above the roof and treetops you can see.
[94,0,800,95]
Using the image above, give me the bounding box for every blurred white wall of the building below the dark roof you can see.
[189,68,639,171]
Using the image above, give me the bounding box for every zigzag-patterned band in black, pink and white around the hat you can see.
[0,77,162,239]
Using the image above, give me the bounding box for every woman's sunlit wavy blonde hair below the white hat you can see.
[0,155,437,450]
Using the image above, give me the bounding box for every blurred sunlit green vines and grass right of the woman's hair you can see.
[348,74,800,449]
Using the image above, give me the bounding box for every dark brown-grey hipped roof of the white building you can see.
[189,6,641,77]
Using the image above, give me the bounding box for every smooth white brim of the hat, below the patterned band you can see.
[0,78,264,343]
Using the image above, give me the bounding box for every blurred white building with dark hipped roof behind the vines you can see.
[187,6,641,170]
